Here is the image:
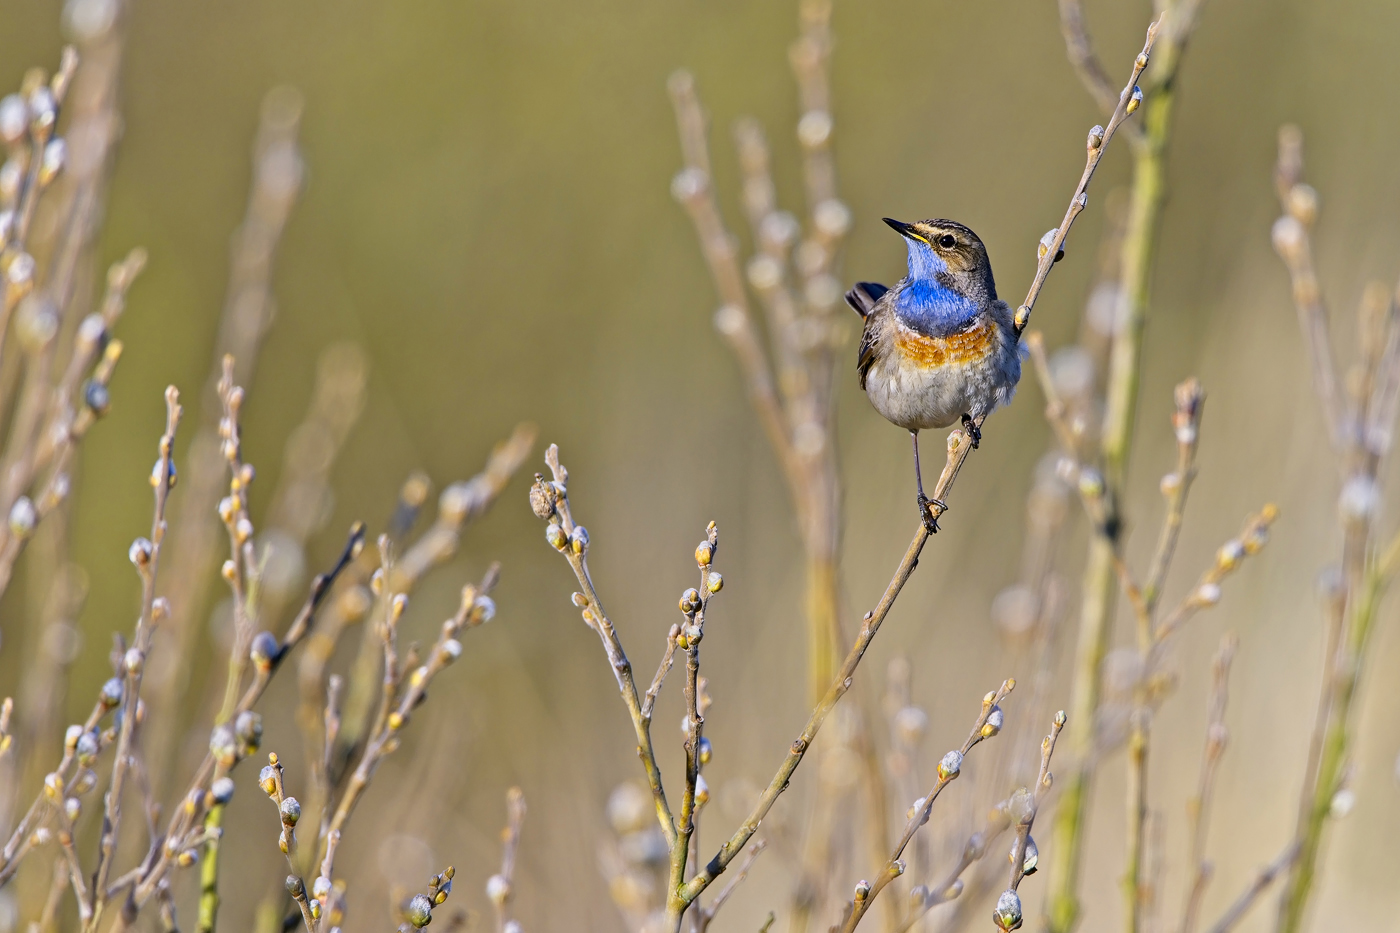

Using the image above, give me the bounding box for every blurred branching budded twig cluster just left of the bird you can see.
[669,0,851,700]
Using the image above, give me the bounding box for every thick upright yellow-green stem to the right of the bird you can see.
[1049,81,1173,933]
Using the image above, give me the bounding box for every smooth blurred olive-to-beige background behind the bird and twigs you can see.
[0,0,1400,930]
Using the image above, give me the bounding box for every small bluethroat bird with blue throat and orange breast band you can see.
[846,217,1021,532]
